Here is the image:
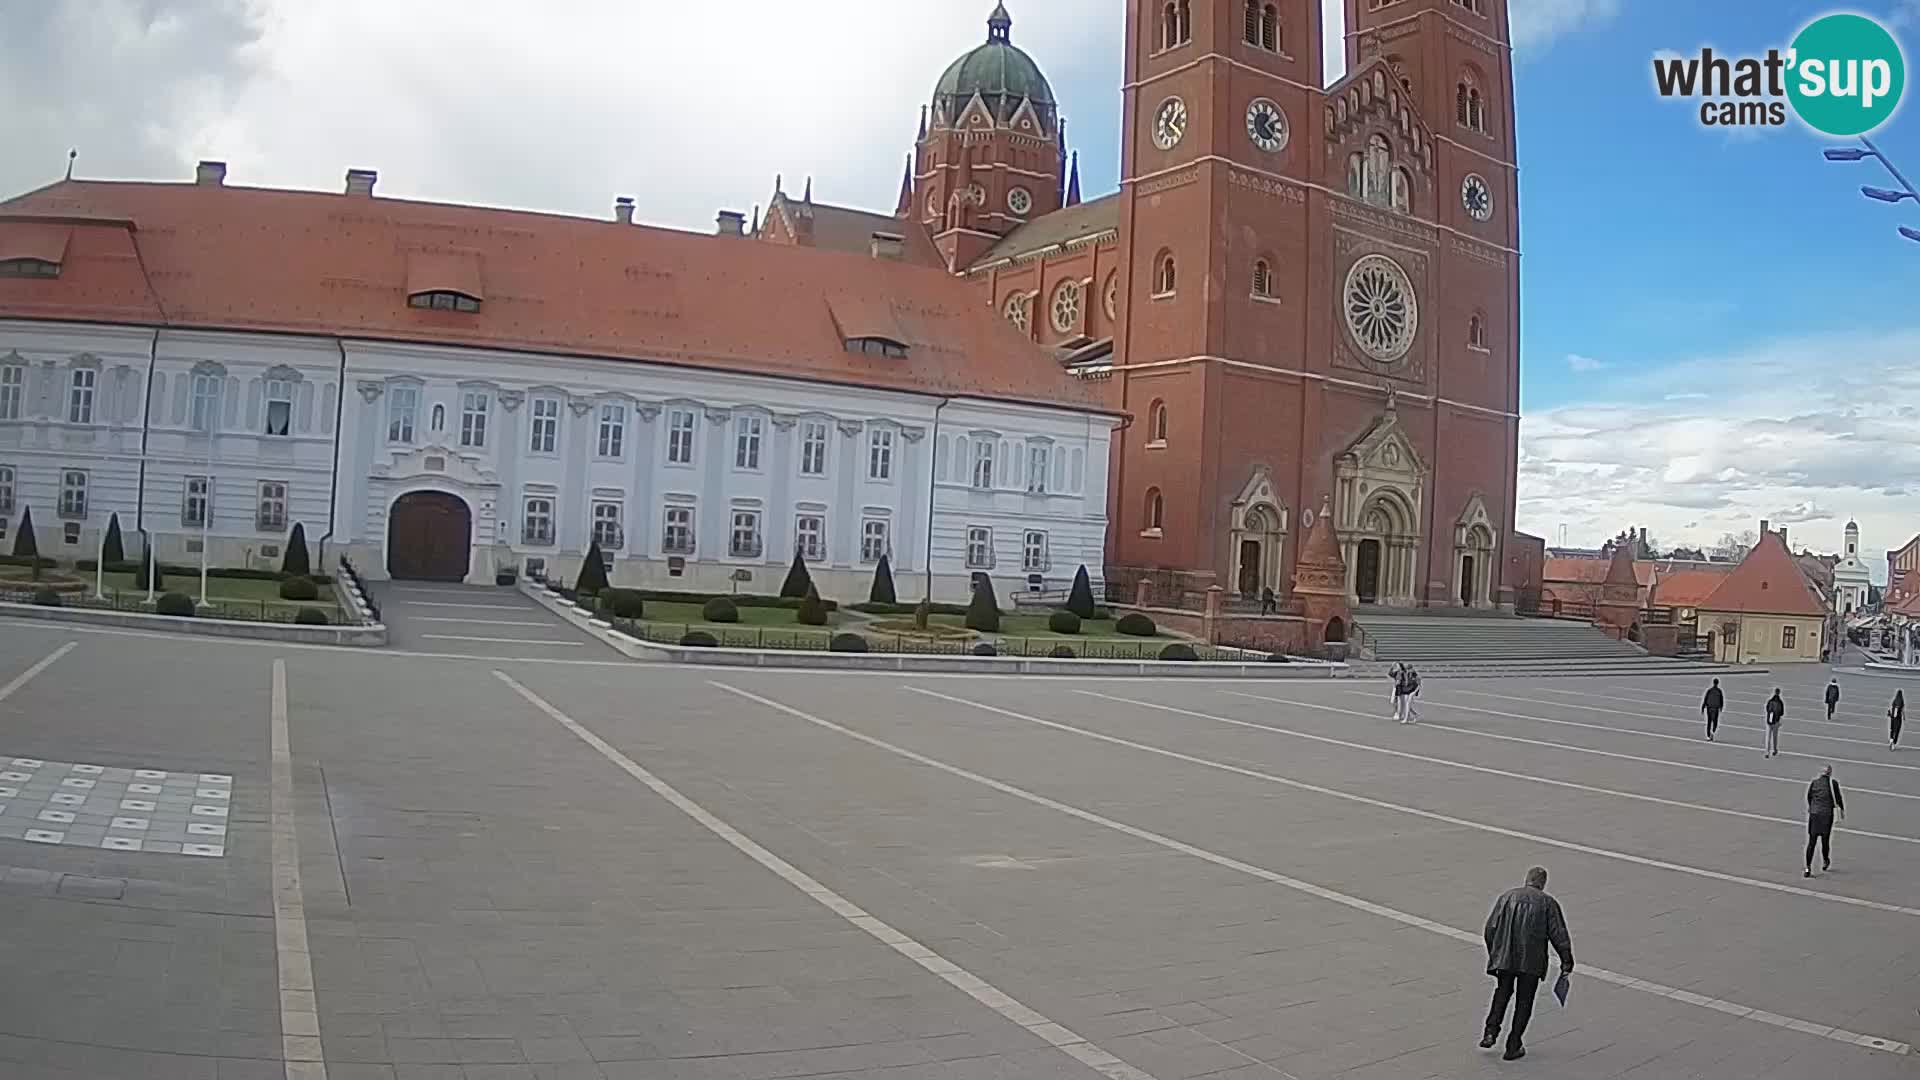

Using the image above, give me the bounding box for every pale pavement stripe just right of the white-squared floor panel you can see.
[273,659,326,1080]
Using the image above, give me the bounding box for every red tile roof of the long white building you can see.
[0,181,1102,407]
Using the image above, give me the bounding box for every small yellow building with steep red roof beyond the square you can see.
[1699,521,1826,663]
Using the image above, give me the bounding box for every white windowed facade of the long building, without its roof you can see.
[0,321,1116,601]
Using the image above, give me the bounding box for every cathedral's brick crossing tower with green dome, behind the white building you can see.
[900,4,1066,271]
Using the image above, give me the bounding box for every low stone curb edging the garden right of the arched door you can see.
[518,582,1348,678]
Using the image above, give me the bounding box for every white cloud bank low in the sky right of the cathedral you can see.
[1519,331,1920,573]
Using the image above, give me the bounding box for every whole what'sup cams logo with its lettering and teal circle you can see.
[1653,13,1907,138]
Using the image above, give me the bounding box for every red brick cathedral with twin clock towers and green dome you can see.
[758,0,1519,607]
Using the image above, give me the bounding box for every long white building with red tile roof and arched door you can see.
[0,163,1119,600]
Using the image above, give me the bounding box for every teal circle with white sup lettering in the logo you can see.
[1788,13,1907,136]
